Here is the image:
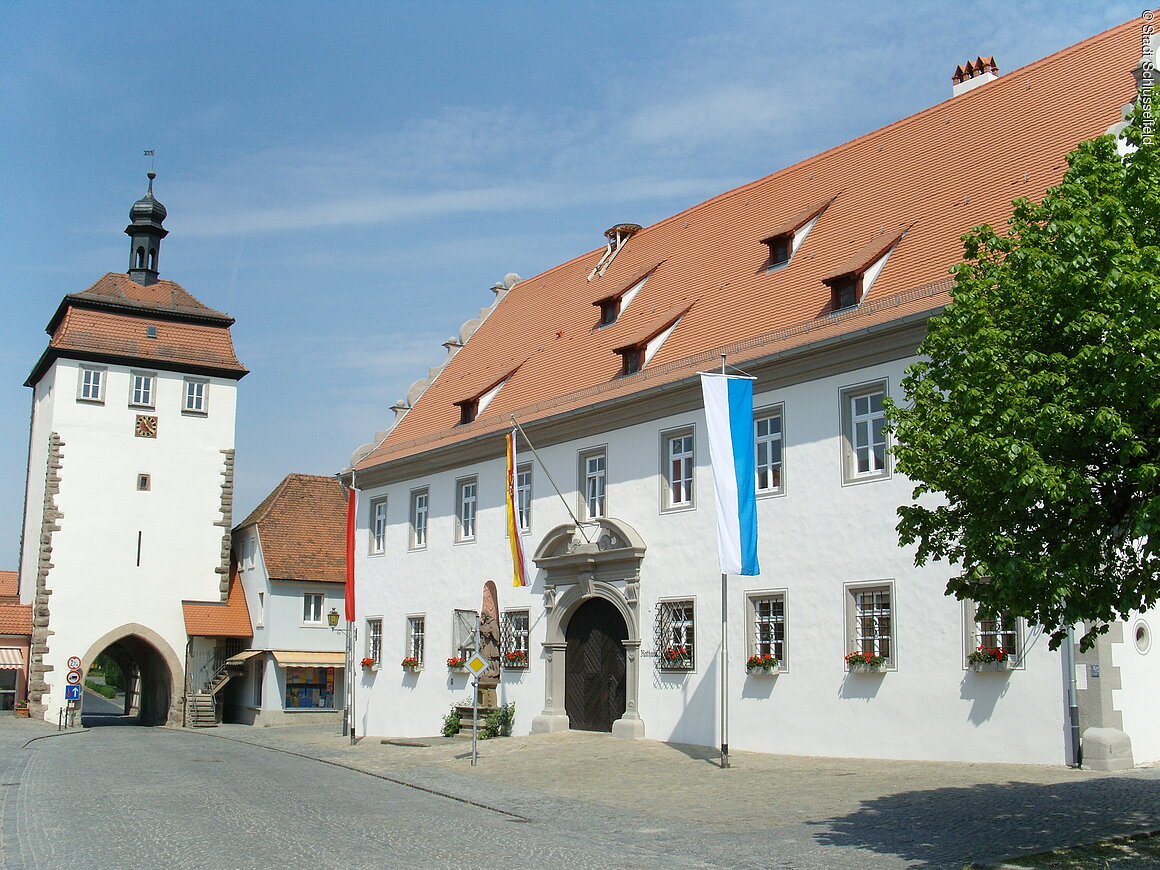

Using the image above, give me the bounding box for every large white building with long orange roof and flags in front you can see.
[345,23,1160,767]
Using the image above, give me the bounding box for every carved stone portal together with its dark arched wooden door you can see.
[531,517,646,738]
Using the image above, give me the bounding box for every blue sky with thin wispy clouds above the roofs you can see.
[0,0,1144,570]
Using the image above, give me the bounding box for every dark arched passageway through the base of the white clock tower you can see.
[81,635,173,726]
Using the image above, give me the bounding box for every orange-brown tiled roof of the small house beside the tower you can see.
[234,474,347,583]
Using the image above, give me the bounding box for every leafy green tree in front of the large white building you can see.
[889,112,1160,648]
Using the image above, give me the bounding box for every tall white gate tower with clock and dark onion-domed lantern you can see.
[20,173,246,724]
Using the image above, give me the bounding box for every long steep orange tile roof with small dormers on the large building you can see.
[355,21,1140,469]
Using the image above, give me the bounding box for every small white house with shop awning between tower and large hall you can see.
[226,474,347,725]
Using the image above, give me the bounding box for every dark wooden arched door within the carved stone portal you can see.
[564,599,629,731]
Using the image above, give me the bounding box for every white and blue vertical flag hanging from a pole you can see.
[701,372,761,577]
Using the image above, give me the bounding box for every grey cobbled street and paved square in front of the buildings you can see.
[0,719,1160,870]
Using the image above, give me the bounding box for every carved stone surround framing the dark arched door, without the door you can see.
[531,517,646,738]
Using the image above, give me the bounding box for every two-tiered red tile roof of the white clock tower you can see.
[26,273,247,386]
